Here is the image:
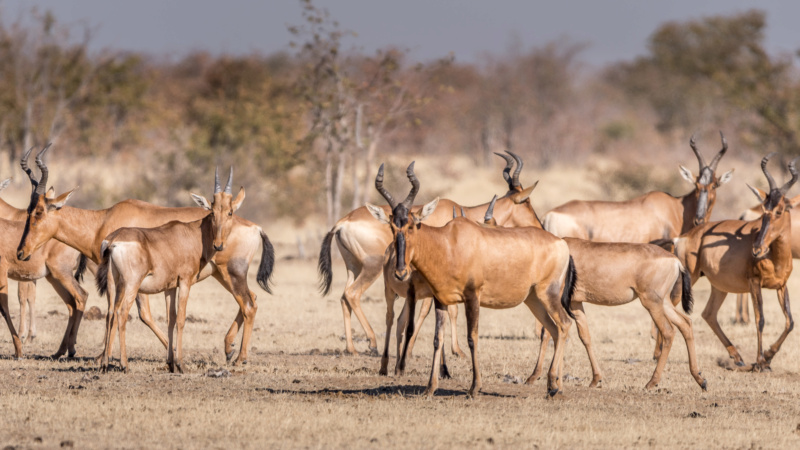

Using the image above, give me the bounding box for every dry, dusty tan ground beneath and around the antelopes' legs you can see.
[0,248,800,448]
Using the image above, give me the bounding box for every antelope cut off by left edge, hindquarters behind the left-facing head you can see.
[0,179,87,358]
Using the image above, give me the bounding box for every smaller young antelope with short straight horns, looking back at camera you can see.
[97,169,244,373]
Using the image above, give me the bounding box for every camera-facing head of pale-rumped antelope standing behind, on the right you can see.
[680,131,733,226]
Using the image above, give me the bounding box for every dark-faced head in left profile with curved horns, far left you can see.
[17,144,77,261]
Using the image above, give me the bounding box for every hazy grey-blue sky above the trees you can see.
[0,0,800,65]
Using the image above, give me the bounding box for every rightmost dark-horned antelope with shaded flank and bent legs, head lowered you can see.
[674,153,798,370]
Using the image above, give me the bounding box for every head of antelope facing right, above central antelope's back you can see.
[495,150,541,227]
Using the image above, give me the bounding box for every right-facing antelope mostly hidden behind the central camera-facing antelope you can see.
[318,153,541,358]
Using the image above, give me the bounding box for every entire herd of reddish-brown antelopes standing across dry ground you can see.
[0,133,800,397]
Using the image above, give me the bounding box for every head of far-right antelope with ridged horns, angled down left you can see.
[747,152,800,259]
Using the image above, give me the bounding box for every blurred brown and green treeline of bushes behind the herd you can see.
[0,6,800,222]
